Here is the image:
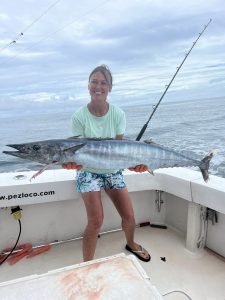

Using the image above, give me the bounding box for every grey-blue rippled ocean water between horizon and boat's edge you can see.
[0,98,225,178]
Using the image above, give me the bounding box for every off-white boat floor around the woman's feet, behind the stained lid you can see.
[0,226,225,300]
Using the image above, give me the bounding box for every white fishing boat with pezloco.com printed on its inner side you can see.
[0,167,225,300]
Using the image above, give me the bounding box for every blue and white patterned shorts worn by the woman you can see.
[76,171,126,193]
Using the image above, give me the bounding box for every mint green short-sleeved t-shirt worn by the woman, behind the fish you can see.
[71,104,126,173]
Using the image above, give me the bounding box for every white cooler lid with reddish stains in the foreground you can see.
[0,253,163,300]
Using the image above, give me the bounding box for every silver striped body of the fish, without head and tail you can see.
[71,140,196,170]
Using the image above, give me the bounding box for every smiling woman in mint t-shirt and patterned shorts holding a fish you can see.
[63,65,151,261]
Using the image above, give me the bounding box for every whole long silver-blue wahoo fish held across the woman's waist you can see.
[3,137,213,181]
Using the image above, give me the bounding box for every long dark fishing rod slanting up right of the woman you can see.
[136,19,212,141]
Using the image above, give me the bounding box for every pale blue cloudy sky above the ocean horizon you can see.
[0,0,225,105]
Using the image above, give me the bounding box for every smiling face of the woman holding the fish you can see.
[88,72,112,100]
